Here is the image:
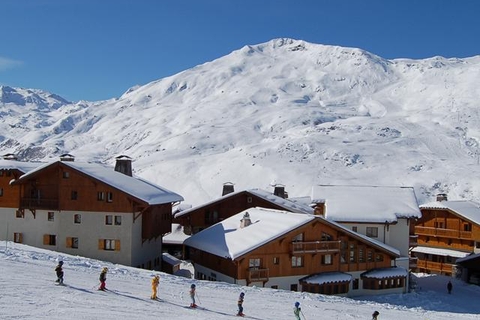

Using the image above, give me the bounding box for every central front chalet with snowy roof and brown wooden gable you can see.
[184,208,408,296]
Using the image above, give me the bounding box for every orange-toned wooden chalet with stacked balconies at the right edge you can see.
[412,194,480,275]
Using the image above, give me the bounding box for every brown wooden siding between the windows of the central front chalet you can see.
[190,219,395,281]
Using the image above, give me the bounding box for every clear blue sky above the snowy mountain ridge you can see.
[0,0,480,101]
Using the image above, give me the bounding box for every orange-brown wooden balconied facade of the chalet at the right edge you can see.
[415,202,480,275]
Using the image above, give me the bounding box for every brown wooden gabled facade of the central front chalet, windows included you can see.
[189,212,398,296]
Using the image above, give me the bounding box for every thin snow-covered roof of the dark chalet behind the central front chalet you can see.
[175,189,313,218]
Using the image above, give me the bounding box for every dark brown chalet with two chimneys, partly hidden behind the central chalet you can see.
[174,184,313,235]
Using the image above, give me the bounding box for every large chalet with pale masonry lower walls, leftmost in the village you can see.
[0,155,183,269]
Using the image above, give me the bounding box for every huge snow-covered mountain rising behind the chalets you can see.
[0,39,480,205]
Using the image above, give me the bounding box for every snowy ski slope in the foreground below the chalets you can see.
[0,241,480,320]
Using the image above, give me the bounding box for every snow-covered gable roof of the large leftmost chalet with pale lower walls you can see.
[11,161,183,205]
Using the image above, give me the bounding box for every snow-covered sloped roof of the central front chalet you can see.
[184,207,400,259]
